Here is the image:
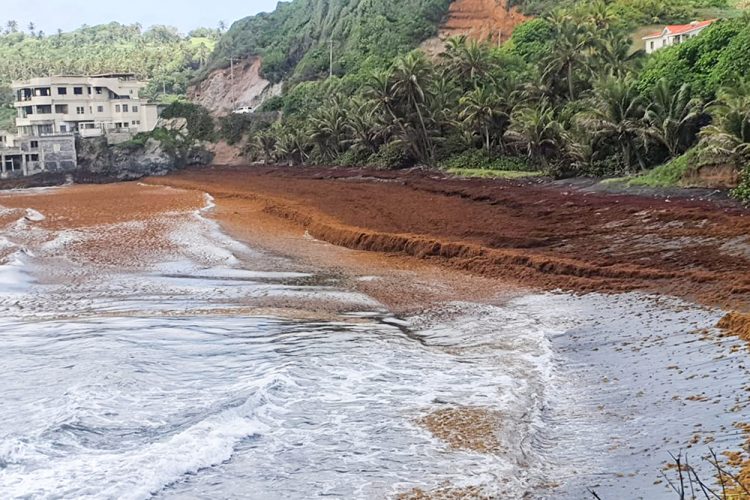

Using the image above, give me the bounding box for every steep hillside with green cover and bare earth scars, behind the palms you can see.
[197,0,528,115]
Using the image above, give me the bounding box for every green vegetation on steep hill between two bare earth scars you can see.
[210,0,450,82]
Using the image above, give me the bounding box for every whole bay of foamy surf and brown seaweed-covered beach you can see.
[0,171,750,498]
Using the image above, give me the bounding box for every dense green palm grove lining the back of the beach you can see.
[197,0,750,201]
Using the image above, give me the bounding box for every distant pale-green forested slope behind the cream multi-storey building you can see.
[0,21,222,128]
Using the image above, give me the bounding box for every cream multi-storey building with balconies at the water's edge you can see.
[12,74,159,137]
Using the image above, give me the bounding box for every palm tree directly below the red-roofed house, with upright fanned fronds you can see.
[646,80,704,158]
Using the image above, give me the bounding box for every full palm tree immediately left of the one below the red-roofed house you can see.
[581,77,648,170]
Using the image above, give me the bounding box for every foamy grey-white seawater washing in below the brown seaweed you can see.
[0,189,747,499]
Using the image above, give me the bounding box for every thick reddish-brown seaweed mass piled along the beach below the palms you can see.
[149,167,750,311]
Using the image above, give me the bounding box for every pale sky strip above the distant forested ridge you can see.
[0,0,277,34]
